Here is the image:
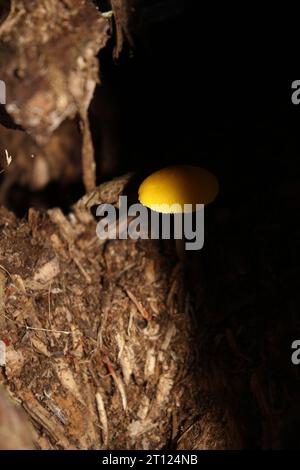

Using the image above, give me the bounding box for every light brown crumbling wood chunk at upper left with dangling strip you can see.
[0,0,109,189]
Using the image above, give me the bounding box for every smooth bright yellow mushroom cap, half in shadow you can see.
[139,165,219,213]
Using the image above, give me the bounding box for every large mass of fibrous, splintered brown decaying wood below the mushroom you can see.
[0,177,228,449]
